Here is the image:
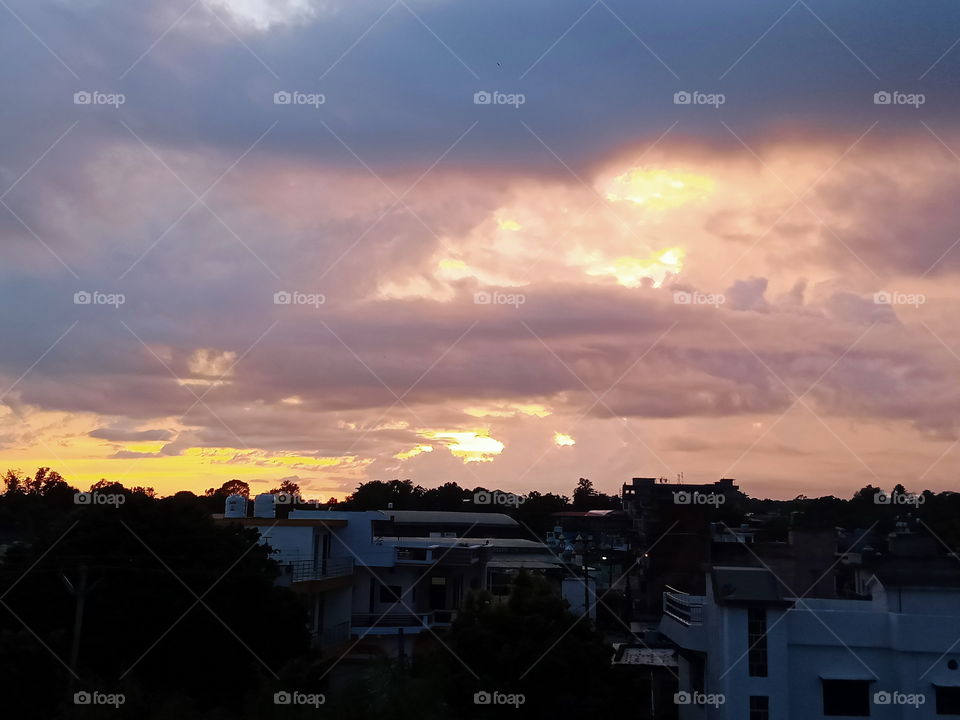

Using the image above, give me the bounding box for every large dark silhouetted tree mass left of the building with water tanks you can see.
[0,483,309,720]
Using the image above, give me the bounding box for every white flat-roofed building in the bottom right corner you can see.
[660,558,960,720]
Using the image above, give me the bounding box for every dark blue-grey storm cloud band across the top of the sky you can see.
[0,0,960,171]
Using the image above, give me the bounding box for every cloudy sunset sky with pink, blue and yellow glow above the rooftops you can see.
[0,0,960,498]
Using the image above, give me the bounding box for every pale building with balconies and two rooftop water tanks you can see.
[218,495,575,655]
